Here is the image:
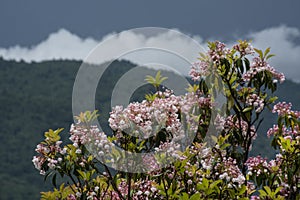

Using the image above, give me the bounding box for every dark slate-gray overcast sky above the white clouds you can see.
[0,0,300,48]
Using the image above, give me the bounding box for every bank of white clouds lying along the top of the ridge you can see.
[0,25,300,82]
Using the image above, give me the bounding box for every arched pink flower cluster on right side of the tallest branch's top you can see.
[243,57,285,83]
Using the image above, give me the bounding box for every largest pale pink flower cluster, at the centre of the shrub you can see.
[108,91,211,141]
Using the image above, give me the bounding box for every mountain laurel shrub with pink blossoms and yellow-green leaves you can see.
[32,41,300,200]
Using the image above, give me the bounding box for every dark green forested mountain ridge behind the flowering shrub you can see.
[0,58,300,199]
